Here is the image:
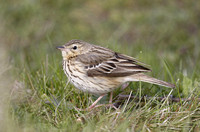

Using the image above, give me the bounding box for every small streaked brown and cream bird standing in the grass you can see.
[56,40,175,109]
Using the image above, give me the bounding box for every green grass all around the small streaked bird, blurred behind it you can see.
[0,0,200,131]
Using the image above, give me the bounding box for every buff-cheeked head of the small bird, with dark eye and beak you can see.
[56,40,92,60]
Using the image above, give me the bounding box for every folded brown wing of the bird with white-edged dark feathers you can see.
[76,47,151,77]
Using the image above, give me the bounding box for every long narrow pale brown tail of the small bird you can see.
[128,73,175,88]
